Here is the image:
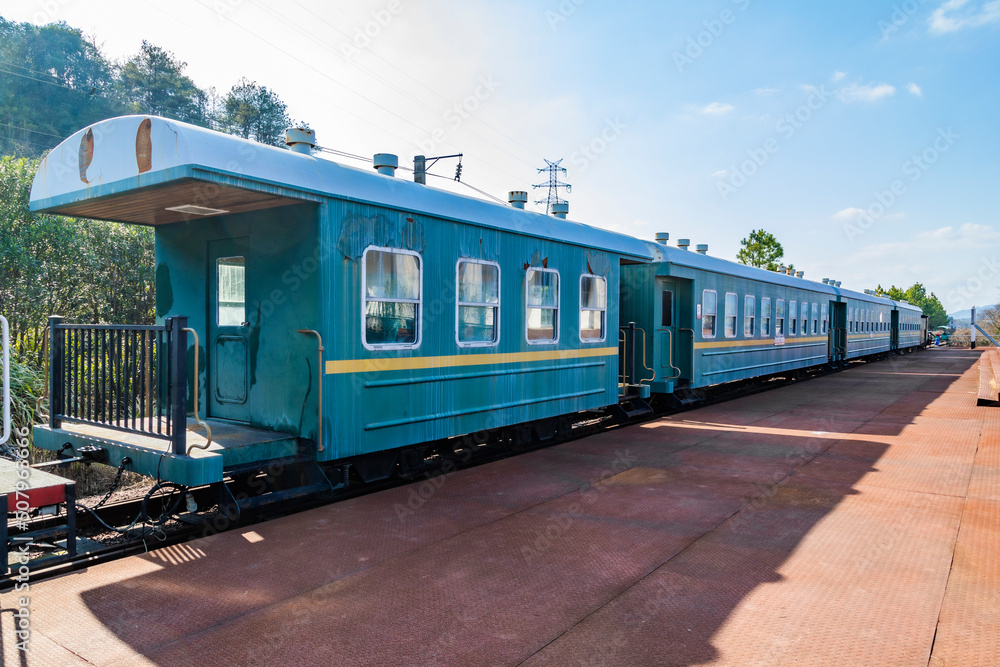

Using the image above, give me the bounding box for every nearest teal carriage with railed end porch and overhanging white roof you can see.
[31,116,652,496]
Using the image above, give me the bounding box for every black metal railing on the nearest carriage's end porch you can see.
[49,316,187,454]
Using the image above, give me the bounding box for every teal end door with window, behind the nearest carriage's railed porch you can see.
[205,238,250,422]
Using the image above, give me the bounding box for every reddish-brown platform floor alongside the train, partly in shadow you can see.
[0,348,1000,666]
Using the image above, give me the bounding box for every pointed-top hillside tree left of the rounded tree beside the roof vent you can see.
[118,40,208,126]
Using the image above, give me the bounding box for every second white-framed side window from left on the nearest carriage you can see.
[455,259,500,347]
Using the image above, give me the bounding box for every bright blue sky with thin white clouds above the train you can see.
[7,0,1000,312]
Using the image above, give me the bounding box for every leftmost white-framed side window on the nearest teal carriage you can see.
[361,247,423,350]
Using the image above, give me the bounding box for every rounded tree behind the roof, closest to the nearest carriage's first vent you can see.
[219,78,292,146]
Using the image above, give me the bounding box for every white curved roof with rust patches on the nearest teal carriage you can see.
[30,116,652,261]
